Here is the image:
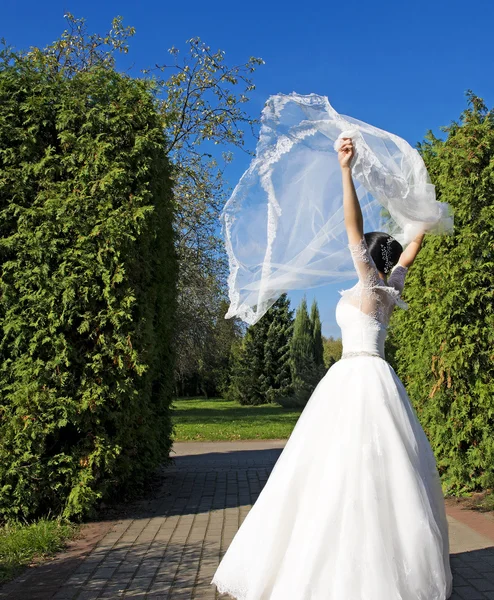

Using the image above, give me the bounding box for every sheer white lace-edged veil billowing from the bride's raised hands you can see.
[221,93,453,324]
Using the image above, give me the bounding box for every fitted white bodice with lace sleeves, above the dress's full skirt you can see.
[336,239,407,358]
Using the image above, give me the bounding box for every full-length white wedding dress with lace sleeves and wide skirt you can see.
[211,240,452,600]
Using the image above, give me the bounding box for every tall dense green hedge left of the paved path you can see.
[0,51,177,519]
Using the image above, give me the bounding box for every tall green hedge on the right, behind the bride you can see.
[390,95,494,494]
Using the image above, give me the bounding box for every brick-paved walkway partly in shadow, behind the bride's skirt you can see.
[0,440,494,600]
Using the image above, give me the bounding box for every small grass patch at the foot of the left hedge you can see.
[0,519,78,584]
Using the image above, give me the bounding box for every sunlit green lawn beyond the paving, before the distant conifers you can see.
[172,398,302,442]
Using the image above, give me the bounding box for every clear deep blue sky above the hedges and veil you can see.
[0,0,494,335]
